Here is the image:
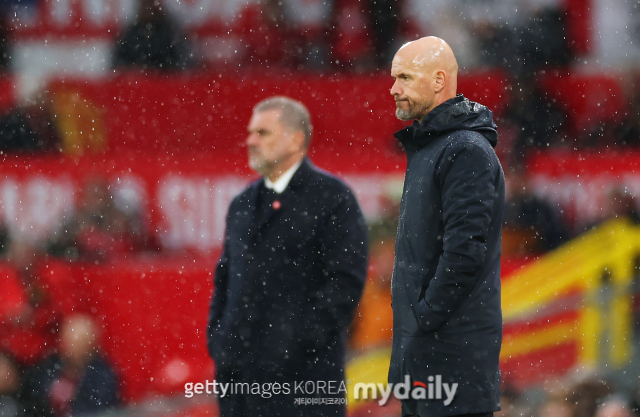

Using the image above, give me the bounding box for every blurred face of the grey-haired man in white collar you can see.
[246,110,304,176]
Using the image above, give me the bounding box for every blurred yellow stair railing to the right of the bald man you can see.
[502,219,640,365]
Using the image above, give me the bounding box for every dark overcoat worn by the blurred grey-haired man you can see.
[209,158,367,407]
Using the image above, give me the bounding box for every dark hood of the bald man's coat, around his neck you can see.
[395,94,498,148]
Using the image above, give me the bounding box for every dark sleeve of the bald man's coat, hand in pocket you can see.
[417,142,499,331]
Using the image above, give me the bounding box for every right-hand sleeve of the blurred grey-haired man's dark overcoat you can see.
[309,188,368,348]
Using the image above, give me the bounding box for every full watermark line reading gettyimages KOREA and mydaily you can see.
[184,375,458,406]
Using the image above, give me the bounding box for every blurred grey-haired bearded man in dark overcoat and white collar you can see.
[208,97,367,417]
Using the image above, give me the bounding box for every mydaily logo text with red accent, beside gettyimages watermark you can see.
[354,375,458,406]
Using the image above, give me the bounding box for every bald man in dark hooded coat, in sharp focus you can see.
[389,37,504,417]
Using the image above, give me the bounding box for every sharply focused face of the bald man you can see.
[391,54,435,121]
